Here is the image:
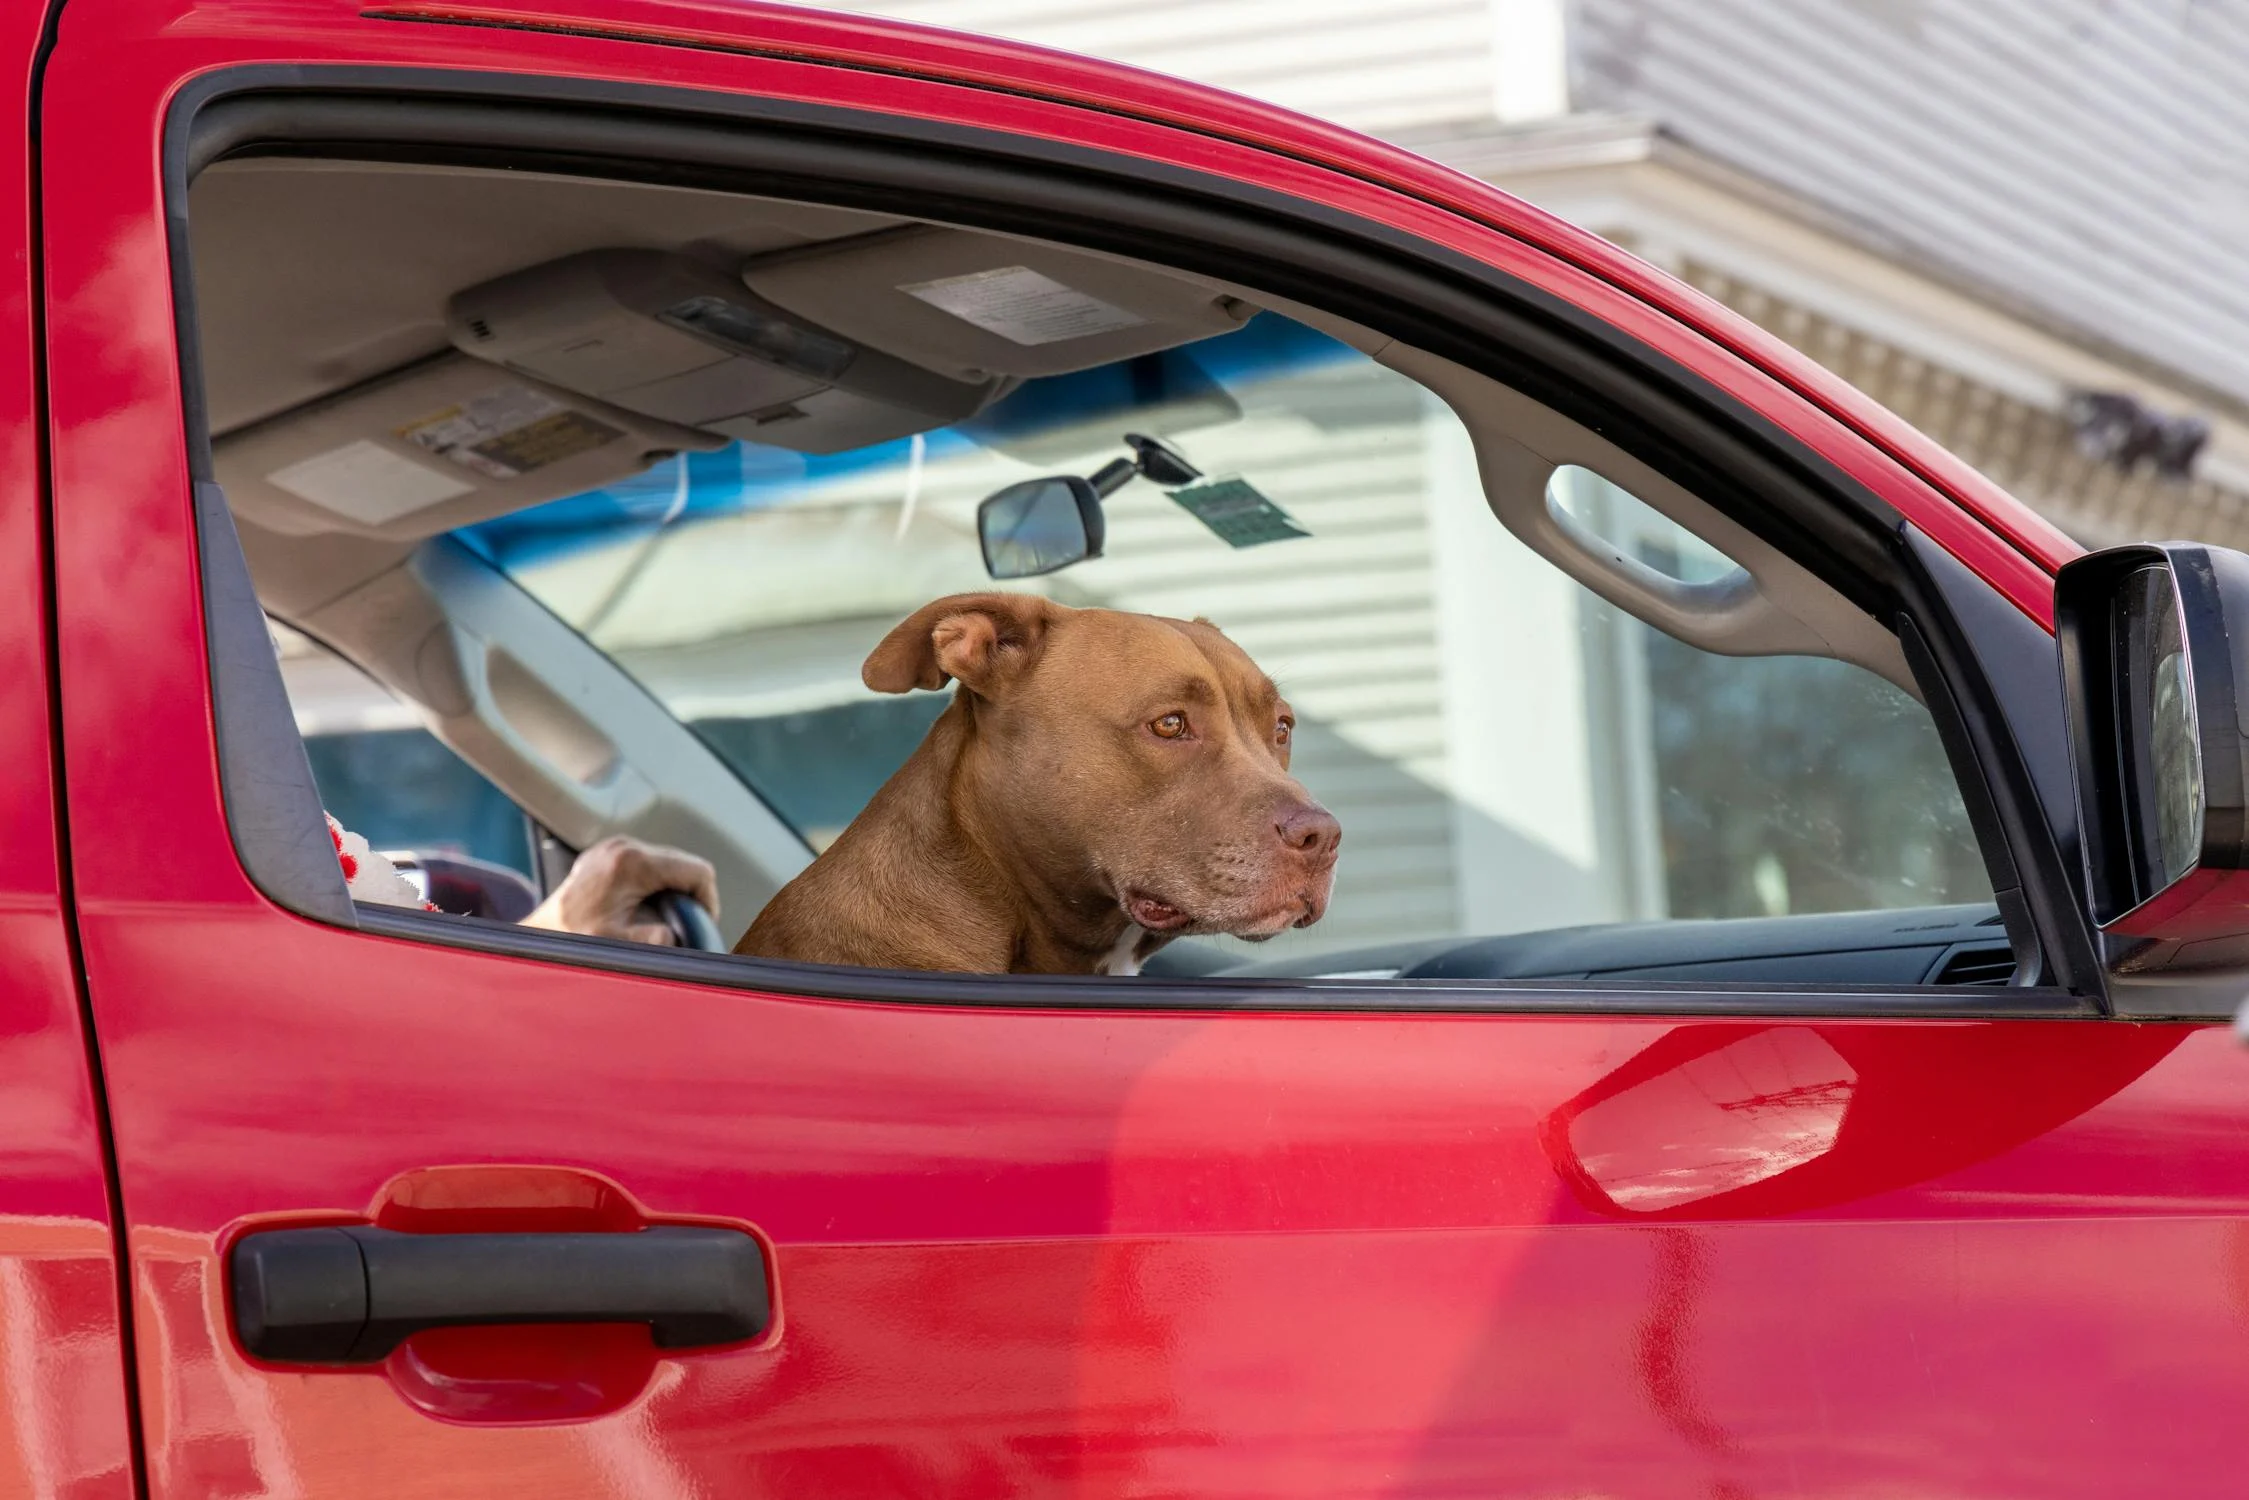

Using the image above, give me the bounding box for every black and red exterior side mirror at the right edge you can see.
[2053,542,2249,972]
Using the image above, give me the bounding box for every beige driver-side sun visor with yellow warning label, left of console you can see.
[211,353,724,540]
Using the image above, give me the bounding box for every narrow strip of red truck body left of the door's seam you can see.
[0,2,133,1500]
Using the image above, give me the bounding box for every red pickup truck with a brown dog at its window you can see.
[0,0,2249,1500]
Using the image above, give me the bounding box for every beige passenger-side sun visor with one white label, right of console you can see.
[742,227,1257,380]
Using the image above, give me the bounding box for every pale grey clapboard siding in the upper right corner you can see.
[1570,0,2249,413]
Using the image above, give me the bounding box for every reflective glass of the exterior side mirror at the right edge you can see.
[2114,564,2202,900]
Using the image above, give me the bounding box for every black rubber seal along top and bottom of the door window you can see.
[164,65,2096,1016]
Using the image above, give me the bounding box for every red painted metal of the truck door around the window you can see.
[30,0,2249,1500]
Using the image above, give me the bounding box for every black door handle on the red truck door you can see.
[229,1223,771,1365]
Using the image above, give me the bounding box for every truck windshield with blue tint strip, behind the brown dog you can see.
[454,313,1988,956]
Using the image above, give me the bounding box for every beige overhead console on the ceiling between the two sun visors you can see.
[448,250,1008,454]
